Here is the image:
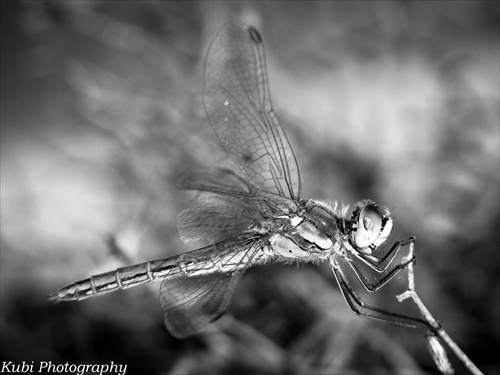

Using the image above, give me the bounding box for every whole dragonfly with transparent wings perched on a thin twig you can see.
[49,23,432,338]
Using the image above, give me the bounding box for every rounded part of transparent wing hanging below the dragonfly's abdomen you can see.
[160,271,243,338]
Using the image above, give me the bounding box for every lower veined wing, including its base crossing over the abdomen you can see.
[160,239,262,338]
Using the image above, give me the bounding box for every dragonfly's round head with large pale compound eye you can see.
[349,199,393,254]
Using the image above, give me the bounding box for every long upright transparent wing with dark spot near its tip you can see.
[203,24,301,200]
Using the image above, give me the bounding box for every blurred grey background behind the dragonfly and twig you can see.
[0,1,500,374]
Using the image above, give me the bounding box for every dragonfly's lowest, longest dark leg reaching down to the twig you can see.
[330,261,435,331]
